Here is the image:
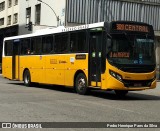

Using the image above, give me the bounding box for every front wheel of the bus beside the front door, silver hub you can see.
[75,73,88,95]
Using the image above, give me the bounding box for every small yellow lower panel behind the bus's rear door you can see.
[2,56,12,79]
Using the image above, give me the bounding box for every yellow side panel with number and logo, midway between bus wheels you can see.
[45,55,66,85]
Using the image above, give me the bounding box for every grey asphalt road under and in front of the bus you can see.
[0,75,160,130]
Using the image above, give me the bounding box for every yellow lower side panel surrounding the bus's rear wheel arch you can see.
[20,55,45,83]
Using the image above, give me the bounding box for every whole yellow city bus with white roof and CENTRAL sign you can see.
[2,21,156,96]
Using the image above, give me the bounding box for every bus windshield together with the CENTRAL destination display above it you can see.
[106,22,156,71]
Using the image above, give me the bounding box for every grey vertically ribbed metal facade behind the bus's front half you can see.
[66,0,160,31]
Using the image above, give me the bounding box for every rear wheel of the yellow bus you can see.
[23,70,31,87]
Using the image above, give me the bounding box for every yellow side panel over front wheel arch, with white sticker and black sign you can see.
[65,54,88,86]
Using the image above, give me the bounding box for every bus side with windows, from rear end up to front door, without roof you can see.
[3,30,88,87]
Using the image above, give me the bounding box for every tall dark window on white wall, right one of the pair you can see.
[35,4,41,25]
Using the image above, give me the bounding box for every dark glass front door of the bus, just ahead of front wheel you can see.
[89,32,102,87]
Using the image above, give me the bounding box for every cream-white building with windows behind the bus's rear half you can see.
[0,0,65,63]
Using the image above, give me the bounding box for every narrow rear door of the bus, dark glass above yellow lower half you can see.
[12,40,20,79]
